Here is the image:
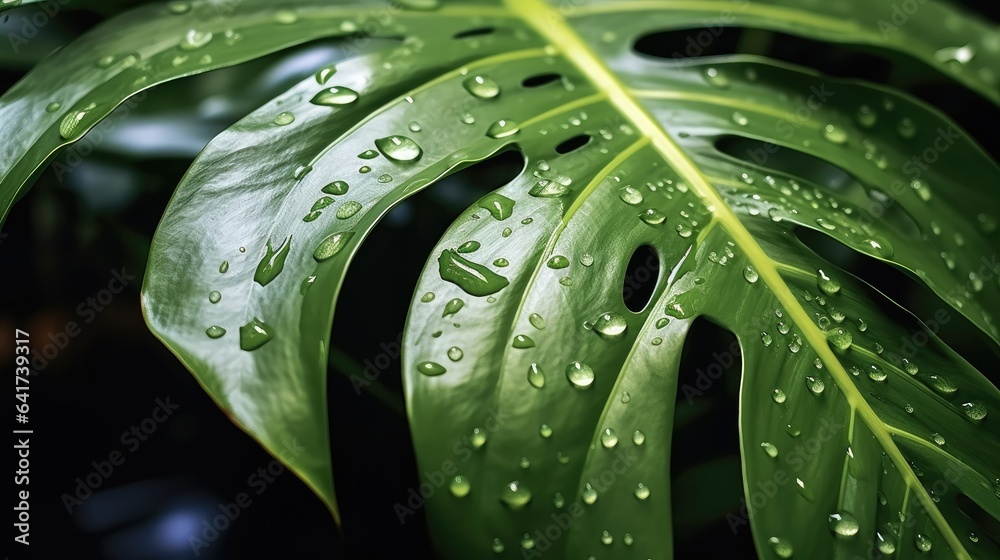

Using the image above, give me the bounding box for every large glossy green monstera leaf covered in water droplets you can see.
[0,0,1000,559]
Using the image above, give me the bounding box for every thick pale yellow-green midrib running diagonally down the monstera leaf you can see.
[504,0,971,560]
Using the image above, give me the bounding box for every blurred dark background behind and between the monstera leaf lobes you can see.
[0,1,1000,560]
